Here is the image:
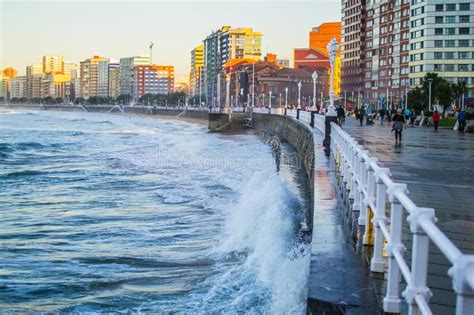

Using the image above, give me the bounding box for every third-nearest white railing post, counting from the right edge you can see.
[383,184,406,314]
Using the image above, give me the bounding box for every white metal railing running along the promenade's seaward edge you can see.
[331,123,474,315]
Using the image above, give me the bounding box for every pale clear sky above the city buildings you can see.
[0,0,341,82]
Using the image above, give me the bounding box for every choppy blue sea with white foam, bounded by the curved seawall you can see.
[0,110,309,314]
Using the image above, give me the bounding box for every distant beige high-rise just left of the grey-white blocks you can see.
[80,56,106,99]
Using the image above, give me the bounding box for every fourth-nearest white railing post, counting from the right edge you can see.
[370,168,389,273]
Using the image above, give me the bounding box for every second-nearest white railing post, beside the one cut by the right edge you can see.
[403,208,436,315]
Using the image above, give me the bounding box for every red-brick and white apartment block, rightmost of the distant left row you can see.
[133,65,174,101]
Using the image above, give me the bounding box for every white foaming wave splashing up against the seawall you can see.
[208,170,310,314]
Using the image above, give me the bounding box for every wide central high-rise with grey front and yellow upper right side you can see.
[204,26,262,105]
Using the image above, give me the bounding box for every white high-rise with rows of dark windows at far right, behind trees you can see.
[409,0,474,97]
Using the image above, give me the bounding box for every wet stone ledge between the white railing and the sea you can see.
[308,122,380,315]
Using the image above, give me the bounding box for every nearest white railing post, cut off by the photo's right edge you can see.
[448,255,474,315]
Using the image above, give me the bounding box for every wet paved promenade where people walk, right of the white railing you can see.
[343,118,474,314]
